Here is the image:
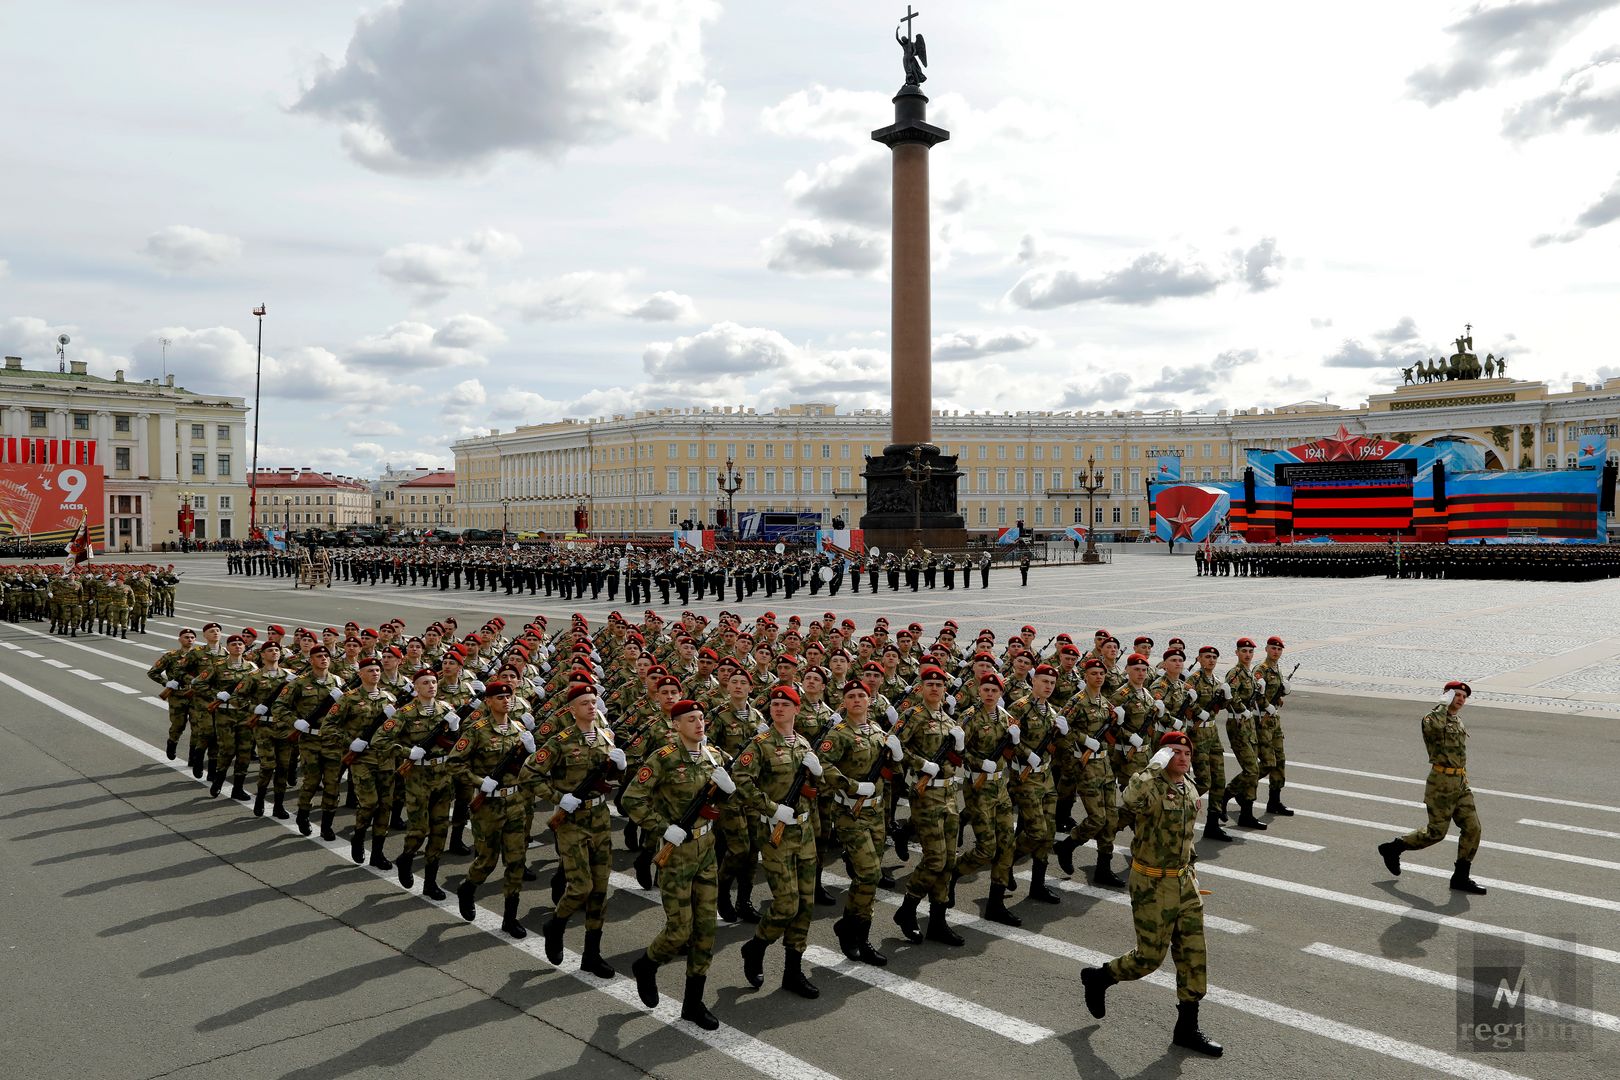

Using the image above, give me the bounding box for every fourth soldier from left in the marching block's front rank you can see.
[889,665,967,946]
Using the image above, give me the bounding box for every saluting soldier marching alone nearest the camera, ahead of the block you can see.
[1081,732,1221,1057]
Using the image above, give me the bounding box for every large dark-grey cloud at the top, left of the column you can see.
[293,0,719,173]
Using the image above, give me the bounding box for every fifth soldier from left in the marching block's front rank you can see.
[951,672,1024,926]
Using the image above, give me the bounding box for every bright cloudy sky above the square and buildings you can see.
[0,0,1620,474]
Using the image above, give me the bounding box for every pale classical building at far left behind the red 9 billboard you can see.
[0,356,251,552]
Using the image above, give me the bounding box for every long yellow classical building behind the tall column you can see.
[452,377,1620,534]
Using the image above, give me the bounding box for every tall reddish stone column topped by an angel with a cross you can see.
[860,6,967,552]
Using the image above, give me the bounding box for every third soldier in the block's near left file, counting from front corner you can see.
[449,680,541,939]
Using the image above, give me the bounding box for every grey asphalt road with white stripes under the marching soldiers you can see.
[0,559,1620,1080]
